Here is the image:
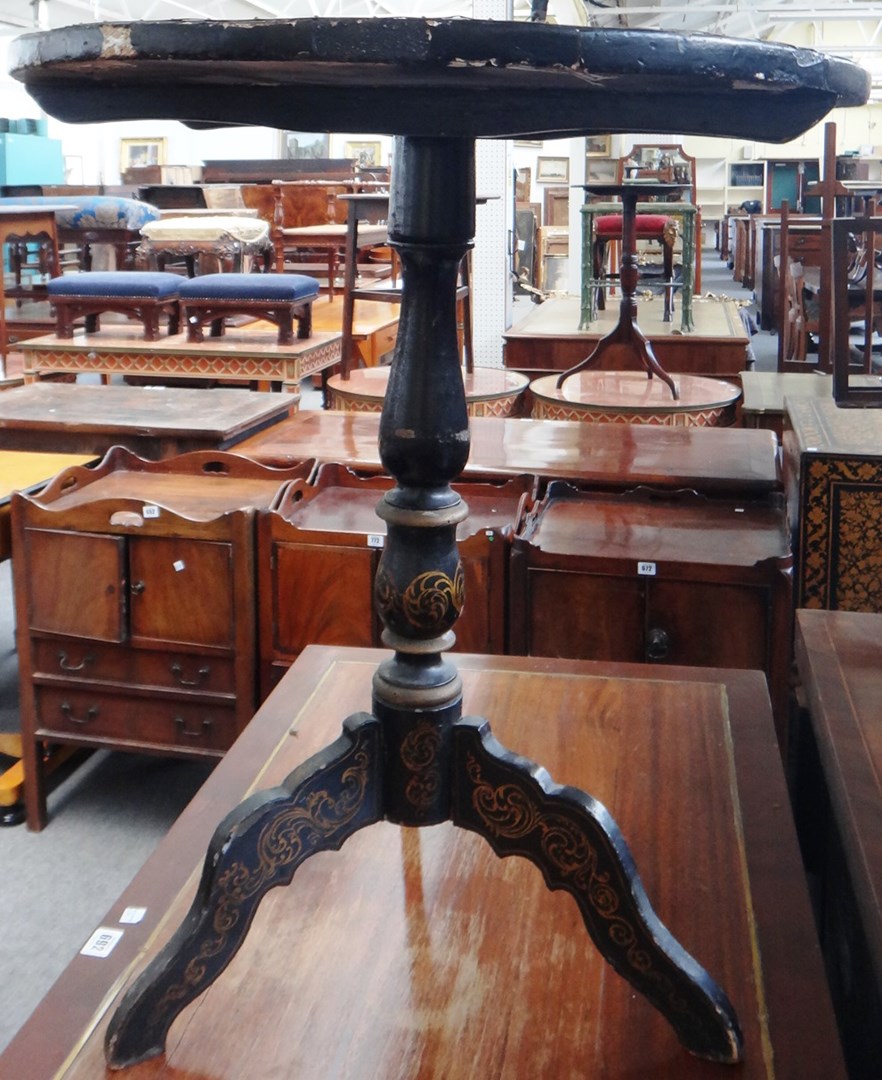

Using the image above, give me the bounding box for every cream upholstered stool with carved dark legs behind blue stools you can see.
[137,212,272,278]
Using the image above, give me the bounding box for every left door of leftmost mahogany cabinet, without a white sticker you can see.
[25,529,125,642]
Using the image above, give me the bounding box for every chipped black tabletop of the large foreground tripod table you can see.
[8,18,870,141]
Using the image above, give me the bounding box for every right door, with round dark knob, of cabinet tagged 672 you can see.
[643,581,771,671]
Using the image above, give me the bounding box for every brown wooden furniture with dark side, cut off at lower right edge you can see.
[795,609,882,1080]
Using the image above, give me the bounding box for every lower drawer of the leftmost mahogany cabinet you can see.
[36,687,239,754]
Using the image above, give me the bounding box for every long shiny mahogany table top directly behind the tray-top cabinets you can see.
[235,410,782,497]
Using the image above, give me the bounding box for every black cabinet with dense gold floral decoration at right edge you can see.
[783,397,882,611]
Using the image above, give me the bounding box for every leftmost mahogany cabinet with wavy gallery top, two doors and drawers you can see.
[12,447,312,829]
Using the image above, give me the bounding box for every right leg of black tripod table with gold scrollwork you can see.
[451,717,742,1063]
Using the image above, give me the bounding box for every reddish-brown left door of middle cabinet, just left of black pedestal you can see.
[273,543,379,658]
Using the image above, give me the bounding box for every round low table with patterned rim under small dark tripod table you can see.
[530,370,741,427]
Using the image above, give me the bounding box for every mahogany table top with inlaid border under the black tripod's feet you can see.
[0,647,843,1080]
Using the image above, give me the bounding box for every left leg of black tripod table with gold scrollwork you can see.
[105,713,382,1068]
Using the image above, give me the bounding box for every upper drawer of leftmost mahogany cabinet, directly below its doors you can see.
[33,638,235,694]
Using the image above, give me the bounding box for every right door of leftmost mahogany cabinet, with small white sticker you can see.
[128,537,234,648]
